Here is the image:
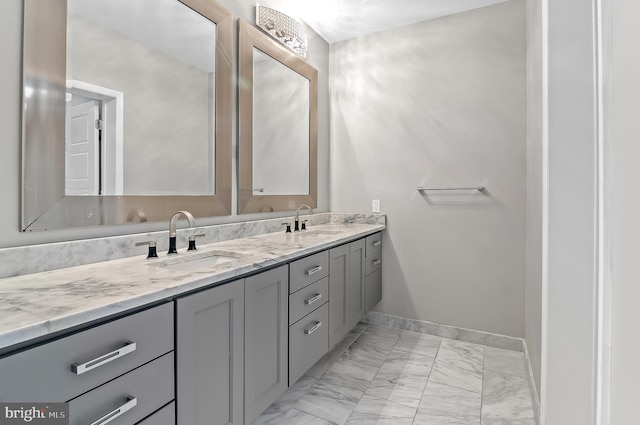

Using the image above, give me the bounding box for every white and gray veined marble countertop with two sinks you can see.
[0,224,385,351]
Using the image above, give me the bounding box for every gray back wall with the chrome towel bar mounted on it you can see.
[330,0,526,337]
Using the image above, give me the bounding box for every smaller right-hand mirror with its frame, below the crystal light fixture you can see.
[238,19,318,214]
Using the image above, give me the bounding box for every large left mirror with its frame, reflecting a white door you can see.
[21,0,233,231]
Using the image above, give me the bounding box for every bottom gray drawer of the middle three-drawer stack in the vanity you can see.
[289,303,329,386]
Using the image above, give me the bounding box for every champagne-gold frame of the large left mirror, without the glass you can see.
[20,0,233,231]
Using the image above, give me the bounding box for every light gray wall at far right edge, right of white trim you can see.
[609,0,640,425]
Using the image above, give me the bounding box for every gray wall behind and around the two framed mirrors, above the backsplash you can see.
[0,0,329,248]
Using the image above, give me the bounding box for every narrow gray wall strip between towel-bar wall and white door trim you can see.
[524,0,543,396]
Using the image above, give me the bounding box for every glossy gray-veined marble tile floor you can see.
[253,322,537,425]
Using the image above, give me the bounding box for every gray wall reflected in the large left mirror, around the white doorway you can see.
[67,16,214,195]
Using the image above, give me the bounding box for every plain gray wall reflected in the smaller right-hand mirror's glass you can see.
[253,49,309,195]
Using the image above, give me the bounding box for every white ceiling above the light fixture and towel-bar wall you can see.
[261,0,506,43]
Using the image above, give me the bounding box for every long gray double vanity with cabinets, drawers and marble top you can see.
[0,217,385,425]
